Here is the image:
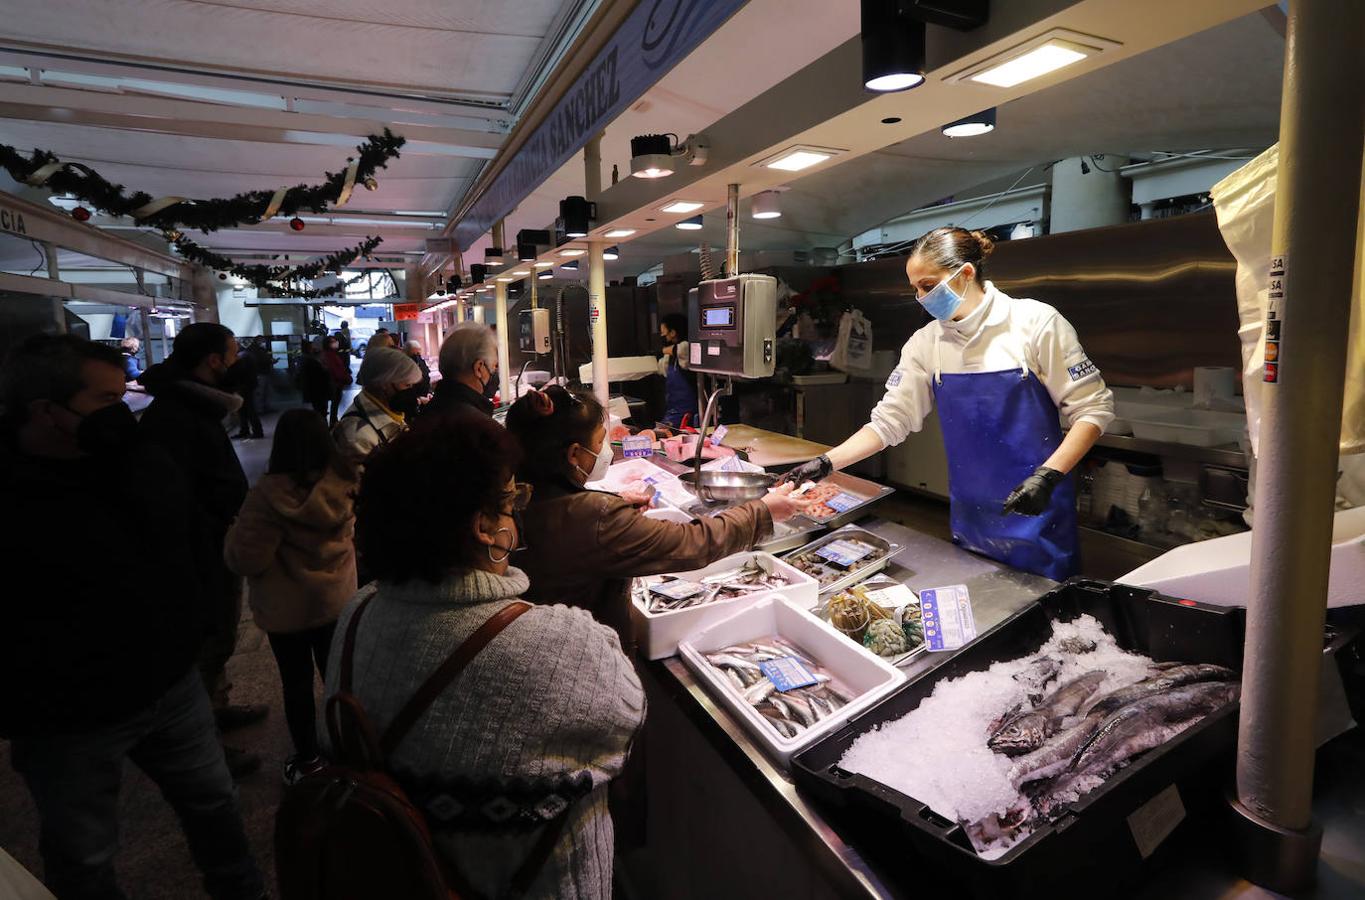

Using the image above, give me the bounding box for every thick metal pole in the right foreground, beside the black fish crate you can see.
[1235,0,1365,890]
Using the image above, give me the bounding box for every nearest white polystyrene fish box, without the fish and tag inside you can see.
[678,595,905,768]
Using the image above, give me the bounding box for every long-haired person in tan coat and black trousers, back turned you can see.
[224,410,356,784]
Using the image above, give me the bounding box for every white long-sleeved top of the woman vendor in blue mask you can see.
[868,281,1114,447]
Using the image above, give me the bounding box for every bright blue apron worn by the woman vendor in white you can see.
[934,352,1077,580]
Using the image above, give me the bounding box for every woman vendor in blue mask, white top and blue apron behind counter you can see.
[788,227,1114,580]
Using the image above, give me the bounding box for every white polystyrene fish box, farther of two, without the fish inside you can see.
[631,550,820,660]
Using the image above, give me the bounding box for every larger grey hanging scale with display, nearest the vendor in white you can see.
[688,275,777,378]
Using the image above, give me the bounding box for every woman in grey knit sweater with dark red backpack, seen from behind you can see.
[276,418,644,900]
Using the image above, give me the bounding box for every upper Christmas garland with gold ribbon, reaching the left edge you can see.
[0,128,407,234]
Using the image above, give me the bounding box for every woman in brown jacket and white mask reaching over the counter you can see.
[506,385,807,653]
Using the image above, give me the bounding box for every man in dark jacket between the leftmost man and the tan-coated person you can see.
[139,322,266,776]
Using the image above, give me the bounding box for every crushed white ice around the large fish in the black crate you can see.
[839,616,1152,859]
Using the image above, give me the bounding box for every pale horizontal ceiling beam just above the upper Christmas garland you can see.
[0,83,502,160]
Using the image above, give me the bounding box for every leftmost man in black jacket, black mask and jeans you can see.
[0,335,265,899]
